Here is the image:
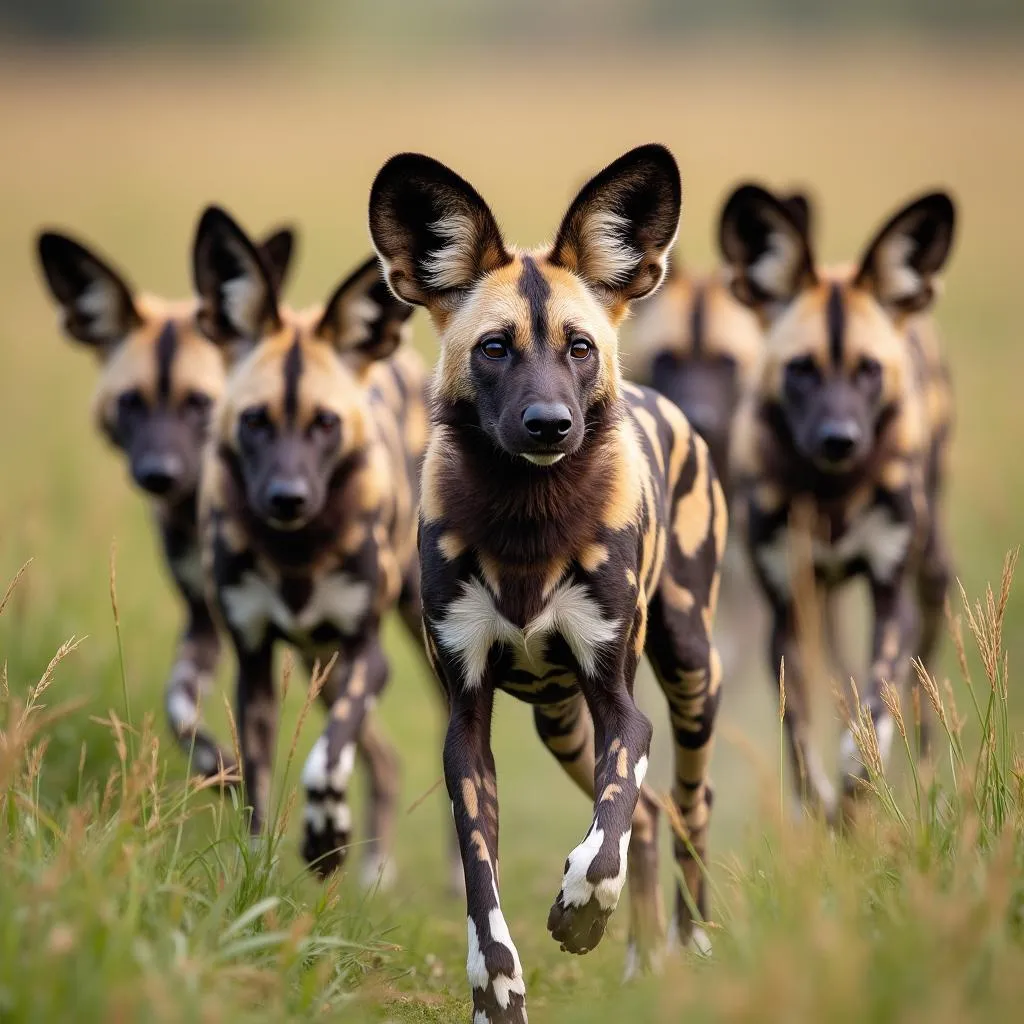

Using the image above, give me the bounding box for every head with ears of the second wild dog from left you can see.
[194,207,412,530]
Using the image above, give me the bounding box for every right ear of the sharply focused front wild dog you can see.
[550,143,683,308]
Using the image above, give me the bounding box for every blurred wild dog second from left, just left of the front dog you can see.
[195,208,428,885]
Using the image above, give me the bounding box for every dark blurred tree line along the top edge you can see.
[0,0,1024,44]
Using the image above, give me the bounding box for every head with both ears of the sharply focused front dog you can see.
[370,145,681,467]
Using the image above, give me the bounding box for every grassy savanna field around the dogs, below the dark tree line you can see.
[0,42,1024,1022]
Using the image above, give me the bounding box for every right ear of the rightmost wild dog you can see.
[854,191,956,316]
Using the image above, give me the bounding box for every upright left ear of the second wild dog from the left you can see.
[193,206,281,345]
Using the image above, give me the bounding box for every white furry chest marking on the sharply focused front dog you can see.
[437,578,618,689]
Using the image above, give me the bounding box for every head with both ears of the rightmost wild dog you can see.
[719,185,955,473]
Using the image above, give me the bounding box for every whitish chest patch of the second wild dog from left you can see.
[220,569,373,649]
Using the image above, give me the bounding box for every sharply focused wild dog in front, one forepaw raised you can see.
[370,145,727,1024]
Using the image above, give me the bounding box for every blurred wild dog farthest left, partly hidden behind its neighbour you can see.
[38,222,295,777]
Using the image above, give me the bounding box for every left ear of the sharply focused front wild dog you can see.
[370,153,512,308]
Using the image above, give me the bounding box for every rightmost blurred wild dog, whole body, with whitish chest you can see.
[720,185,955,818]
